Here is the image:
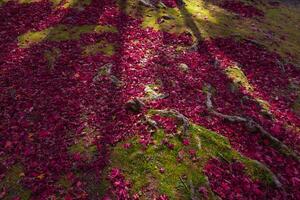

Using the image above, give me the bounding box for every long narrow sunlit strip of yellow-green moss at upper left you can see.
[18,25,116,48]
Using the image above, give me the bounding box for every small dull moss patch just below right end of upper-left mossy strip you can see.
[84,40,115,56]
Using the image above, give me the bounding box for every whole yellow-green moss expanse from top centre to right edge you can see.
[119,0,300,64]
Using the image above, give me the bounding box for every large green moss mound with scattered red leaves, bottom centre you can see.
[111,111,281,199]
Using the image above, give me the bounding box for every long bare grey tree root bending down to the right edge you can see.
[205,85,300,162]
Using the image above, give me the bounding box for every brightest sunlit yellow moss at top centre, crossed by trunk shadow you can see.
[119,0,221,39]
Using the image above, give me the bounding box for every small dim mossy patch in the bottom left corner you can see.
[0,165,31,200]
